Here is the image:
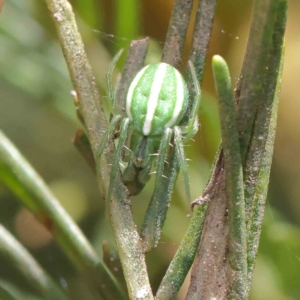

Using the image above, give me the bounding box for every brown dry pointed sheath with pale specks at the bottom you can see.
[186,155,229,300]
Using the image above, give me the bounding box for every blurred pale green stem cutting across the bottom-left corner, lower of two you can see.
[0,225,68,300]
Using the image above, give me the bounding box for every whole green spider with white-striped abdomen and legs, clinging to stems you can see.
[97,51,200,205]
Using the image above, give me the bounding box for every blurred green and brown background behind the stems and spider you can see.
[0,0,300,300]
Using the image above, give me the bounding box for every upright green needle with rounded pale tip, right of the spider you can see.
[212,55,247,300]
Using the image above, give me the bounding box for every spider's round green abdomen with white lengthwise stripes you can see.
[125,63,188,136]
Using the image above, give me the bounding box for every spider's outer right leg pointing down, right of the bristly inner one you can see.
[174,126,192,203]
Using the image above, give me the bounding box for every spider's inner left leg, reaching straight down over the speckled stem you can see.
[106,118,130,207]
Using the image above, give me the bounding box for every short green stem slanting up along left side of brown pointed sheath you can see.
[155,203,207,300]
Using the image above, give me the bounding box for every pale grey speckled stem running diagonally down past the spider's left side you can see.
[45,0,153,299]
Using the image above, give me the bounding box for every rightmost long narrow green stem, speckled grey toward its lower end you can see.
[247,0,287,293]
